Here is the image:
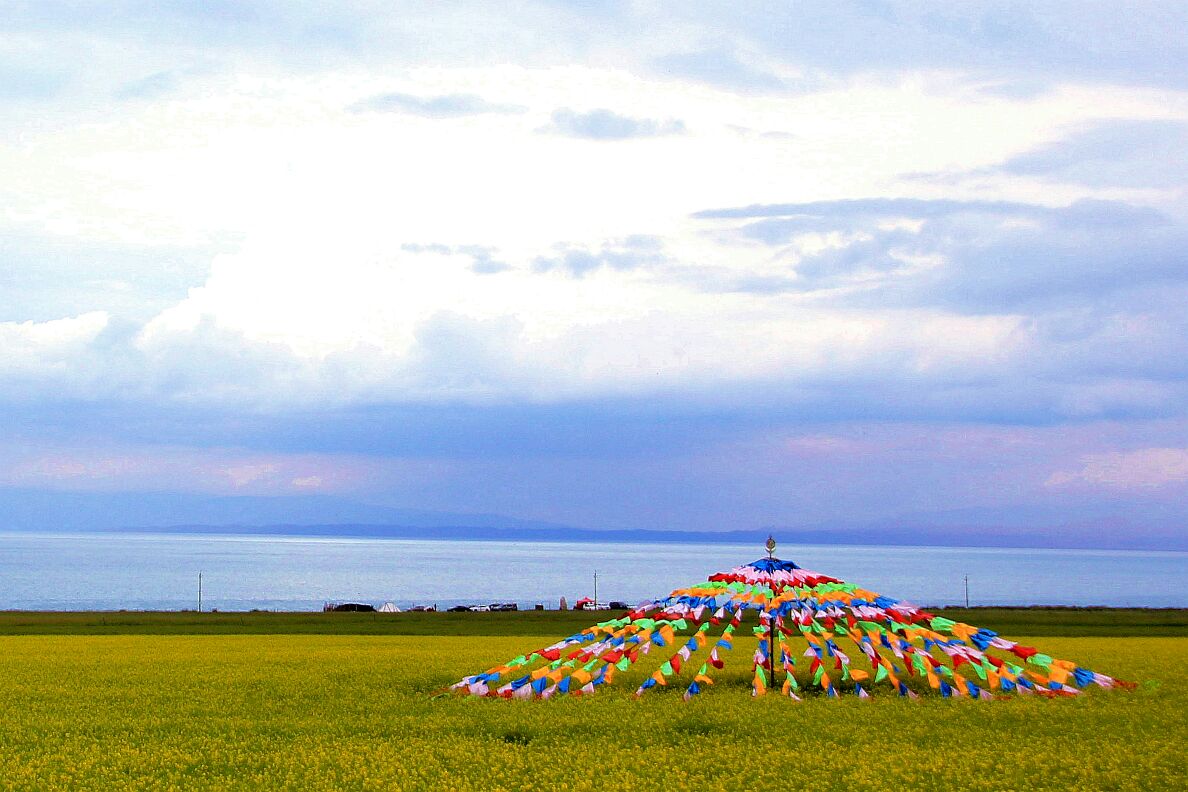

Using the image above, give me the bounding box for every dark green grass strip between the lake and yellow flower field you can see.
[0,608,1188,636]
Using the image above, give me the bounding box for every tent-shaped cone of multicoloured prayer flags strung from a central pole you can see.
[449,539,1133,701]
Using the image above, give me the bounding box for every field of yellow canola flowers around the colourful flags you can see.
[0,635,1188,791]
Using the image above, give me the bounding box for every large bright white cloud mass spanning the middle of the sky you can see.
[0,31,1186,412]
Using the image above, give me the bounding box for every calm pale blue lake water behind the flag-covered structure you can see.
[0,533,1188,610]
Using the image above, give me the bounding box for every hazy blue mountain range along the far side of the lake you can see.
[0,489,1188,550]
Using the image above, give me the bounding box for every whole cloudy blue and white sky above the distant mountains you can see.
[0,0,1188,539]
